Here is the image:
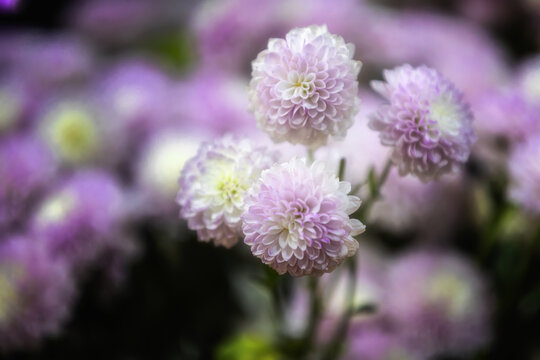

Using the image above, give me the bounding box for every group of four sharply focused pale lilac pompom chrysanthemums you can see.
[177,26,475,276]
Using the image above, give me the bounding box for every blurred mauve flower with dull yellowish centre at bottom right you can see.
[386,251,491,355]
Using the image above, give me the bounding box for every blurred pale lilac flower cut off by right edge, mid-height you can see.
[508,133,540,214]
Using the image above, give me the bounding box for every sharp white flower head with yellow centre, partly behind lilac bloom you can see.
[177,137,275,248]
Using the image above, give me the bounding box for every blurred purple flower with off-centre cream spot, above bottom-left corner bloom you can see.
[31,170,126,269]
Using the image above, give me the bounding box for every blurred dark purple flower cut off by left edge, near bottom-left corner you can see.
[0,237,74,351]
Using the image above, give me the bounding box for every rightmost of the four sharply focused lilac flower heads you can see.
[370,65,475,181]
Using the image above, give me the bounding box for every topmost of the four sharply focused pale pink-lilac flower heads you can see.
[249,26,361,148]
